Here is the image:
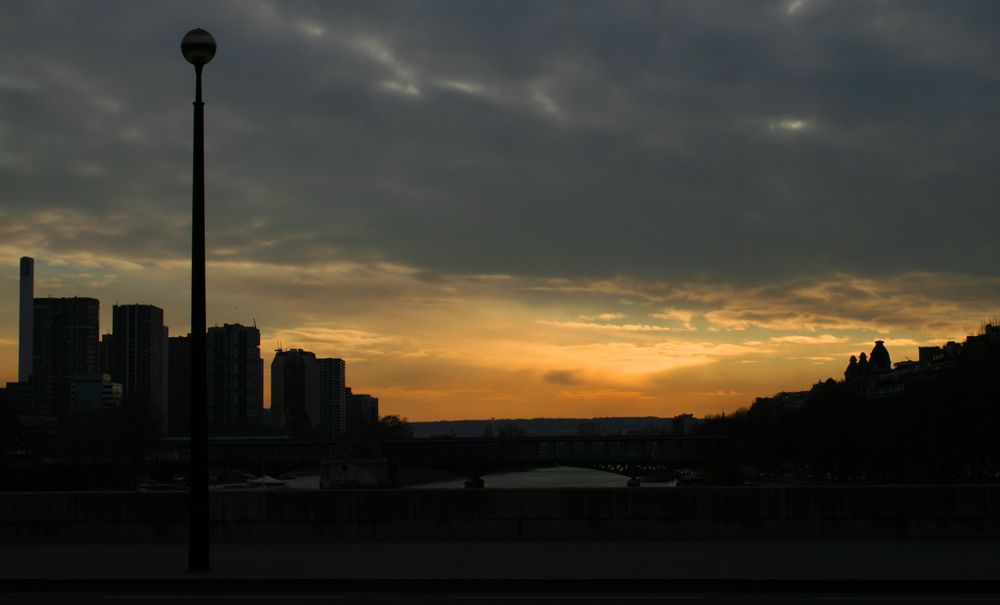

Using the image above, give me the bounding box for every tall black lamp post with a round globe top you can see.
[181,28,215,571]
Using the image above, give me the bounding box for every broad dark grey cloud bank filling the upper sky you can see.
[0,0,1000,281]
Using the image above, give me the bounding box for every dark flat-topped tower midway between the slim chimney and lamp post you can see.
[111,305,167,431]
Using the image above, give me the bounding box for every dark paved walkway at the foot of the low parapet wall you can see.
[0,541,1000,583]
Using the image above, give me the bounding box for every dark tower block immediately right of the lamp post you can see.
[207,324,264,430]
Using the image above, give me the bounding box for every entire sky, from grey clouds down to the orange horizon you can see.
[0,0,1000,420]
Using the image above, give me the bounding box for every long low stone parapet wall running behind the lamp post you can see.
[0,485,1000,543]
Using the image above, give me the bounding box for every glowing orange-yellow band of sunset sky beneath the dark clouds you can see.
[0,254,995,420]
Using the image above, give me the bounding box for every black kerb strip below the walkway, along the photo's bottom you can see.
[0,575,1000,595]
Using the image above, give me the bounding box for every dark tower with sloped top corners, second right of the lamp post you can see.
[271,349,319,434]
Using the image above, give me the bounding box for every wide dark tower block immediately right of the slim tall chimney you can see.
[31,297,101,414]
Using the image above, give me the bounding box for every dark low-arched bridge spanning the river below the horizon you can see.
[145,435,731,487]
